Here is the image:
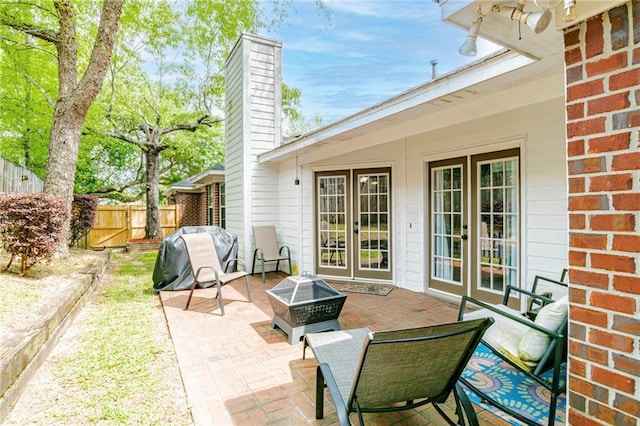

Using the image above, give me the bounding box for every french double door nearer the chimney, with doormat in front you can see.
[315,168,392,280]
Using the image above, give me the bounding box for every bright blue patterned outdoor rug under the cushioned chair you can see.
[462,344,567,425]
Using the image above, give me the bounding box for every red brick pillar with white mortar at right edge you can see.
[564,0,640,425]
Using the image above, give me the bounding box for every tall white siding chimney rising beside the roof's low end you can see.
[225,33,282,270]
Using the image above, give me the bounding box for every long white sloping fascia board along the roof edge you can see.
[258,51,535,164]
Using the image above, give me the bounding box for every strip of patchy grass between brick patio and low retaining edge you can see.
[2,252,193,425]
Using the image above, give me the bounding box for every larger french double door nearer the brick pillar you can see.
[428,149,520,303]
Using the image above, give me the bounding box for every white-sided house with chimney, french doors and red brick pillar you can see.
[225,0,640,424]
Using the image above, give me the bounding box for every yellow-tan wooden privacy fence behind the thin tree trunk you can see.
[86,205,178,248]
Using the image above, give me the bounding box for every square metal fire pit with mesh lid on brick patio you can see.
[267,274,347,345]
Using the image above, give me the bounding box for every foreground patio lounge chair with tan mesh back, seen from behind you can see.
[303,318,493,425]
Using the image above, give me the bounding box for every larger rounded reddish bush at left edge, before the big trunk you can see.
[0,192,67,275]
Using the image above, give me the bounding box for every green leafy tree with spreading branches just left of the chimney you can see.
[84,0,324,238]
